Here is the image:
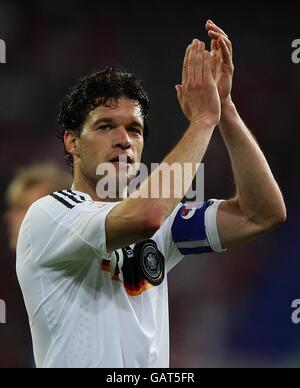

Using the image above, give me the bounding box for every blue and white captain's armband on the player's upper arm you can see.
[172,200,224,256]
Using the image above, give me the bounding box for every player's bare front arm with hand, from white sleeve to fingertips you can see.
[106,39,221,251]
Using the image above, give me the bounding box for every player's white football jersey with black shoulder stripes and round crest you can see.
[17,190,222,368]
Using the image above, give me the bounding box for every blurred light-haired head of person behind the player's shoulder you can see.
[6,162,72,251]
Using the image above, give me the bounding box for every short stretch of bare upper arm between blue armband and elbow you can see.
[217,198,274,249]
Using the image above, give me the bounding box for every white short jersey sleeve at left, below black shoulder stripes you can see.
[20,198,117,265]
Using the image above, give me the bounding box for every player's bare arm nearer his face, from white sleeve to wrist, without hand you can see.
[107,119,215,252]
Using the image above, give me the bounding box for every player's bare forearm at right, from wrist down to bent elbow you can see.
[219,104,286,223]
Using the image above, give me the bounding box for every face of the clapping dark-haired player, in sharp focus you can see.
[74,98,144,190]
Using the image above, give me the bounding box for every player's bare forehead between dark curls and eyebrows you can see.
[88,98,143,124]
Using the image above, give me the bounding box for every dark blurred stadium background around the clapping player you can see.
[0,0,300,367]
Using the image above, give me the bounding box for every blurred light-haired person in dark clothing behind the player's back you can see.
[0,162,72,368]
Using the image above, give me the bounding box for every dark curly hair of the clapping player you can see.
[57,67,150,169]
